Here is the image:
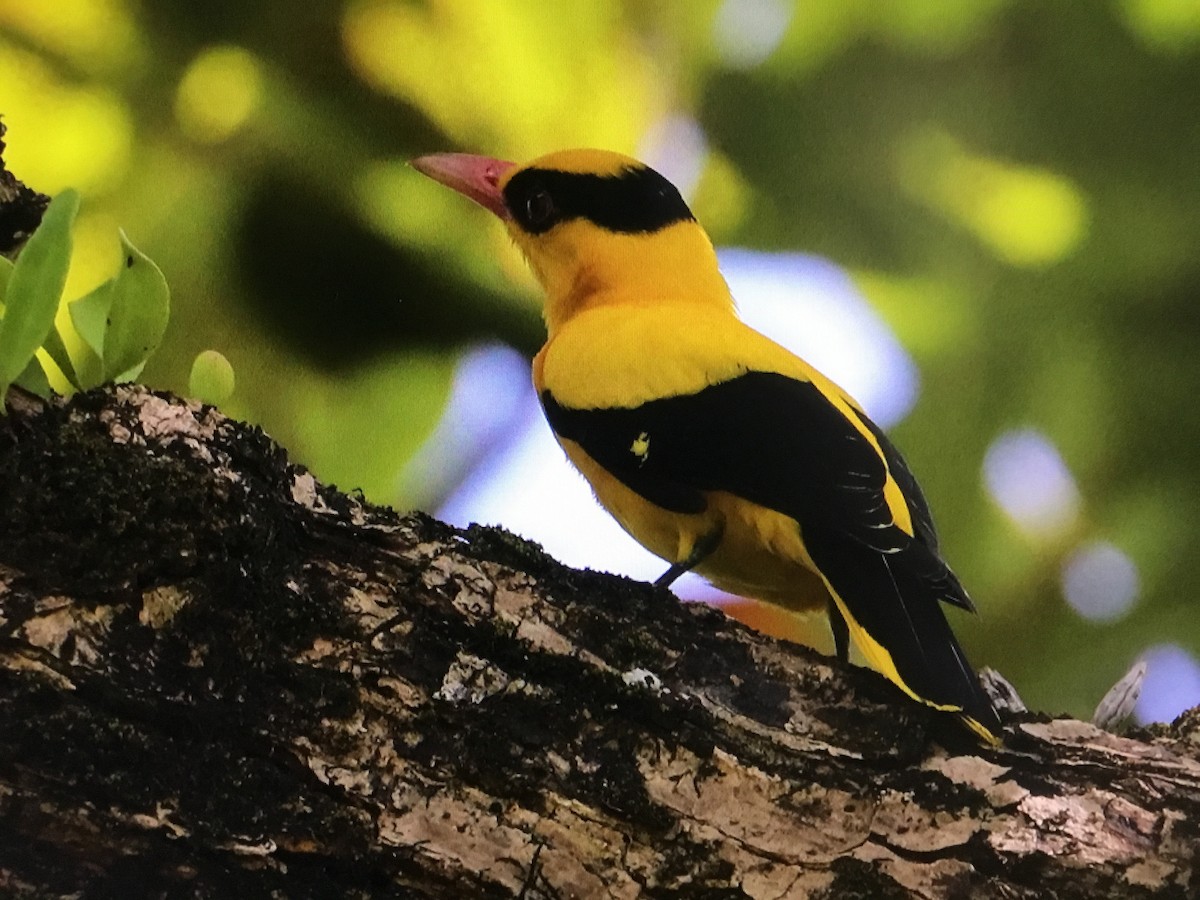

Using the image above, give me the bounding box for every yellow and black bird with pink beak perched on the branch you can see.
[412,150,1001,745]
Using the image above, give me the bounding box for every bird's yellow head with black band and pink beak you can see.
[413,150,732,334]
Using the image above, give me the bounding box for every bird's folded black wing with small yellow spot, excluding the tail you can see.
[541,372,937,556]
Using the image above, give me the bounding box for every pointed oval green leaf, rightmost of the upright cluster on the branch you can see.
[101,232,170,379]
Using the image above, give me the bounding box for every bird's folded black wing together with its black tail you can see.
[541,372,995,724]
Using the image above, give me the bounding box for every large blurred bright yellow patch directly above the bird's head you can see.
[342,0,662,158]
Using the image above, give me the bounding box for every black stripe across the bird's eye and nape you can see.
[504,167,694,234]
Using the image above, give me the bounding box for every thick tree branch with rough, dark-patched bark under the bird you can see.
[0,388,1200,899]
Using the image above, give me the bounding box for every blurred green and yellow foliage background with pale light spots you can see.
[0,0,1200,721]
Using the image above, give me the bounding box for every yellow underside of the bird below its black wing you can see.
[560,440,829,612]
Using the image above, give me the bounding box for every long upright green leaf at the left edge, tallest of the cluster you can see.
[0,190,79,397]
